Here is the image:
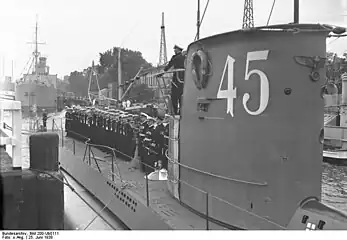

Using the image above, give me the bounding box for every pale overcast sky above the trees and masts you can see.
[0,0,347,79]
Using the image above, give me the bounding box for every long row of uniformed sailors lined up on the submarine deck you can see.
[65,107,169,172]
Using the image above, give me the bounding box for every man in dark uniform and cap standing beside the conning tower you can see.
[164,45,185,115]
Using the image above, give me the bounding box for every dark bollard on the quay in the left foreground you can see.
[29,133,64,230]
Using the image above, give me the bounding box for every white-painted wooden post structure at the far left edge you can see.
[0,93,22,168]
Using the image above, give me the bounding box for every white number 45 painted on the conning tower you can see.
[217,50,269,117]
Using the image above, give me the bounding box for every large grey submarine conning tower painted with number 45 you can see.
[175,24,340,229]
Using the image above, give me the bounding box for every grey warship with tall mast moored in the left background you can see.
[15,17,57,116]
